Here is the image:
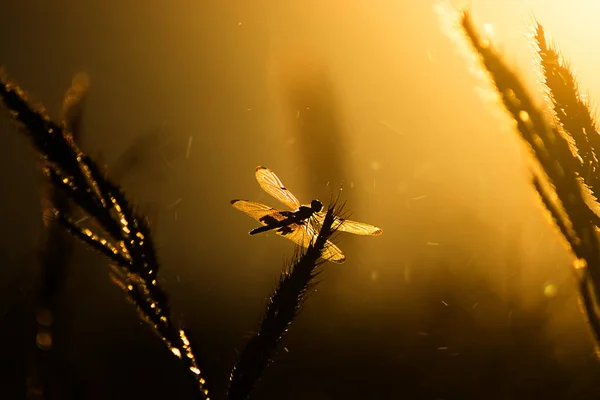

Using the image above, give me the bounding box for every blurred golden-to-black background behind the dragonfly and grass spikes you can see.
[0,0,600,400]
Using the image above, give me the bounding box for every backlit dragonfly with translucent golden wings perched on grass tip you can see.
[231,166,383,264]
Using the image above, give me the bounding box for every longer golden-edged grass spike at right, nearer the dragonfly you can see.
[461,12,600,354]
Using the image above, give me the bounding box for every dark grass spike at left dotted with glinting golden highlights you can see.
[0,75,209,400]
